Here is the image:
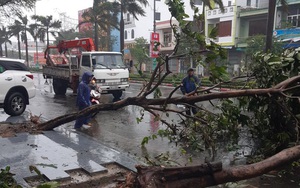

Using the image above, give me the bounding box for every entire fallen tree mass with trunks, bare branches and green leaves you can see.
[29,0,300,188]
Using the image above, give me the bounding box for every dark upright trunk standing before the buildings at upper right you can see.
[265,0,288,52]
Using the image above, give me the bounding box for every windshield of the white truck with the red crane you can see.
[92,54,125,69]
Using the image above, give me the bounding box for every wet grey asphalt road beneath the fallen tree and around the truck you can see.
[0,73,210,164]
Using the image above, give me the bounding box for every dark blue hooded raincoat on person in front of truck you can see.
[76,72,93,108]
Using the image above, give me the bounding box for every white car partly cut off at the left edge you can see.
[0,58,35,116]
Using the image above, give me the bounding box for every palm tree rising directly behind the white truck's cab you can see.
[79,0,119,49]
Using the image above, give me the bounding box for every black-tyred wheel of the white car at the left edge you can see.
[4,92,26,116]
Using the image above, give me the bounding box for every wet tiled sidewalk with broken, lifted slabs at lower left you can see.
[0,125,138,187]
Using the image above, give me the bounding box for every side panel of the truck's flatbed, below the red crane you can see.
[43,65,79,80]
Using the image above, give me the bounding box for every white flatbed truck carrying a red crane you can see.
[43,38,129,99]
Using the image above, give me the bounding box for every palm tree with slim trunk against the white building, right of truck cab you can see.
[118,0,148,53]
